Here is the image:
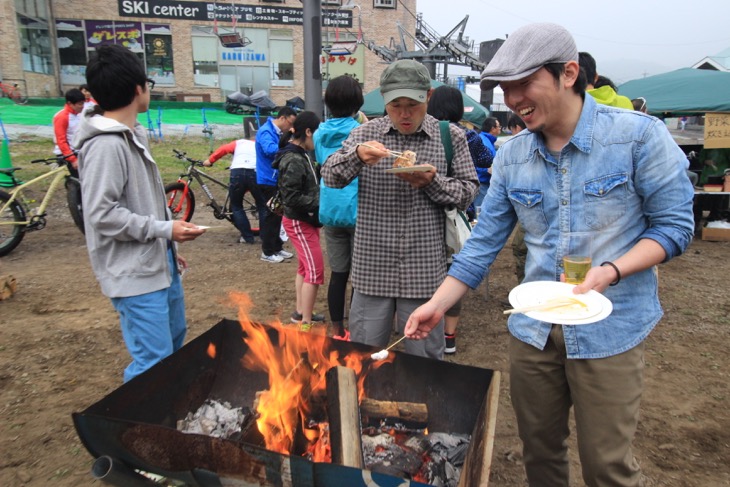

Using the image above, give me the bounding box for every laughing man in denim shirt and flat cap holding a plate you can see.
[405,24,693,486]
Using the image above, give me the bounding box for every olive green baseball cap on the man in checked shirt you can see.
[380,59,431,105]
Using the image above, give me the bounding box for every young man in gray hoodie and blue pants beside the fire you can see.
[74,45,205,382]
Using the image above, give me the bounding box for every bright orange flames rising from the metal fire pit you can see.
[225,292,394,461]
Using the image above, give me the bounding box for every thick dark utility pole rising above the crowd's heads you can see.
[302,0,324,118]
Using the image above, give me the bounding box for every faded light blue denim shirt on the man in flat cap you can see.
[449,96,694,359]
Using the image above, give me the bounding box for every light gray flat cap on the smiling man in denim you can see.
[480,22,578,90]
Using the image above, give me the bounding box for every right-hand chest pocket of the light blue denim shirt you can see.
[583,172,629,230]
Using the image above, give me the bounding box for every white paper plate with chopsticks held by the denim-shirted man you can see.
[509,281,613,325]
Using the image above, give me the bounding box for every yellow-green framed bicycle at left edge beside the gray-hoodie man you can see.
[0,156,84,257]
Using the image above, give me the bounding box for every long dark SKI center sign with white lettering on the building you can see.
[118,0,352,27]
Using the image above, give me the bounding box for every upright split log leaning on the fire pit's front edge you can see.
[326,366,364,468]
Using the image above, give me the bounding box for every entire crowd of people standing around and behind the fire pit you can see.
[68,23,716,486]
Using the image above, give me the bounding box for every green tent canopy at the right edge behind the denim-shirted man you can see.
[618,68,730,116]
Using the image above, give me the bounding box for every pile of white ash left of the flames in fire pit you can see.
[177,399,246,438]
